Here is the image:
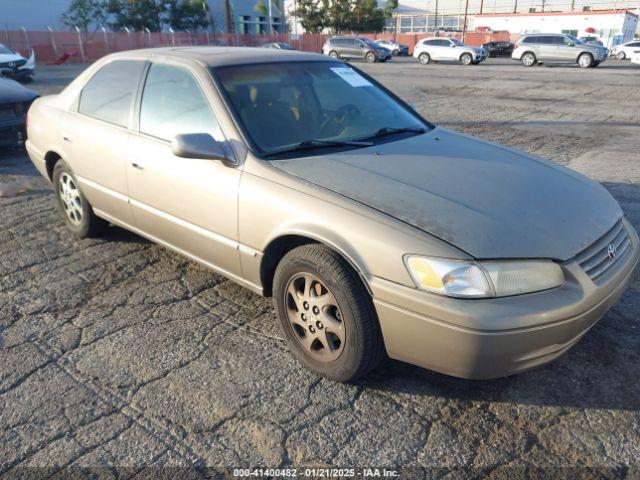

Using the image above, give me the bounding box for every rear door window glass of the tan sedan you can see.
[78,60,145,127]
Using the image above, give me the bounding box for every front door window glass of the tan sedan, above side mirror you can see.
[140,63,222,141]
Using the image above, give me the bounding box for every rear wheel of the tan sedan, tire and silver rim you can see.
[52,160,109,238]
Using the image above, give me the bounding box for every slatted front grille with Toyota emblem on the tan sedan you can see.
[576,220,631,283]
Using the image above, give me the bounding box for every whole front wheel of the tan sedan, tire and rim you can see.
[273,244,385,382]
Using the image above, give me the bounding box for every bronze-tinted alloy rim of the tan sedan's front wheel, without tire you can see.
[284,273,346,363]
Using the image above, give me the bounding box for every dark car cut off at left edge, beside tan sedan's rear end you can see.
[0,77,38,147]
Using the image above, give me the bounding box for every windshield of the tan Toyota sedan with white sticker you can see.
[212,61,431,156]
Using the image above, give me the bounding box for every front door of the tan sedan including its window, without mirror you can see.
[128,63,241,277]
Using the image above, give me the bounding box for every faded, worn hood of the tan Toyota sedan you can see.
[271,128,622,260]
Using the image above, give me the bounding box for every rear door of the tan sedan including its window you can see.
[60,60,146,225]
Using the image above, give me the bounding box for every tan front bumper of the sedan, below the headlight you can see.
[367,220,640,379]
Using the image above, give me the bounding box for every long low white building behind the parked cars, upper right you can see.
[469,7,638,47]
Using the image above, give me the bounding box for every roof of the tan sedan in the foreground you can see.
[104,46,328,67]
